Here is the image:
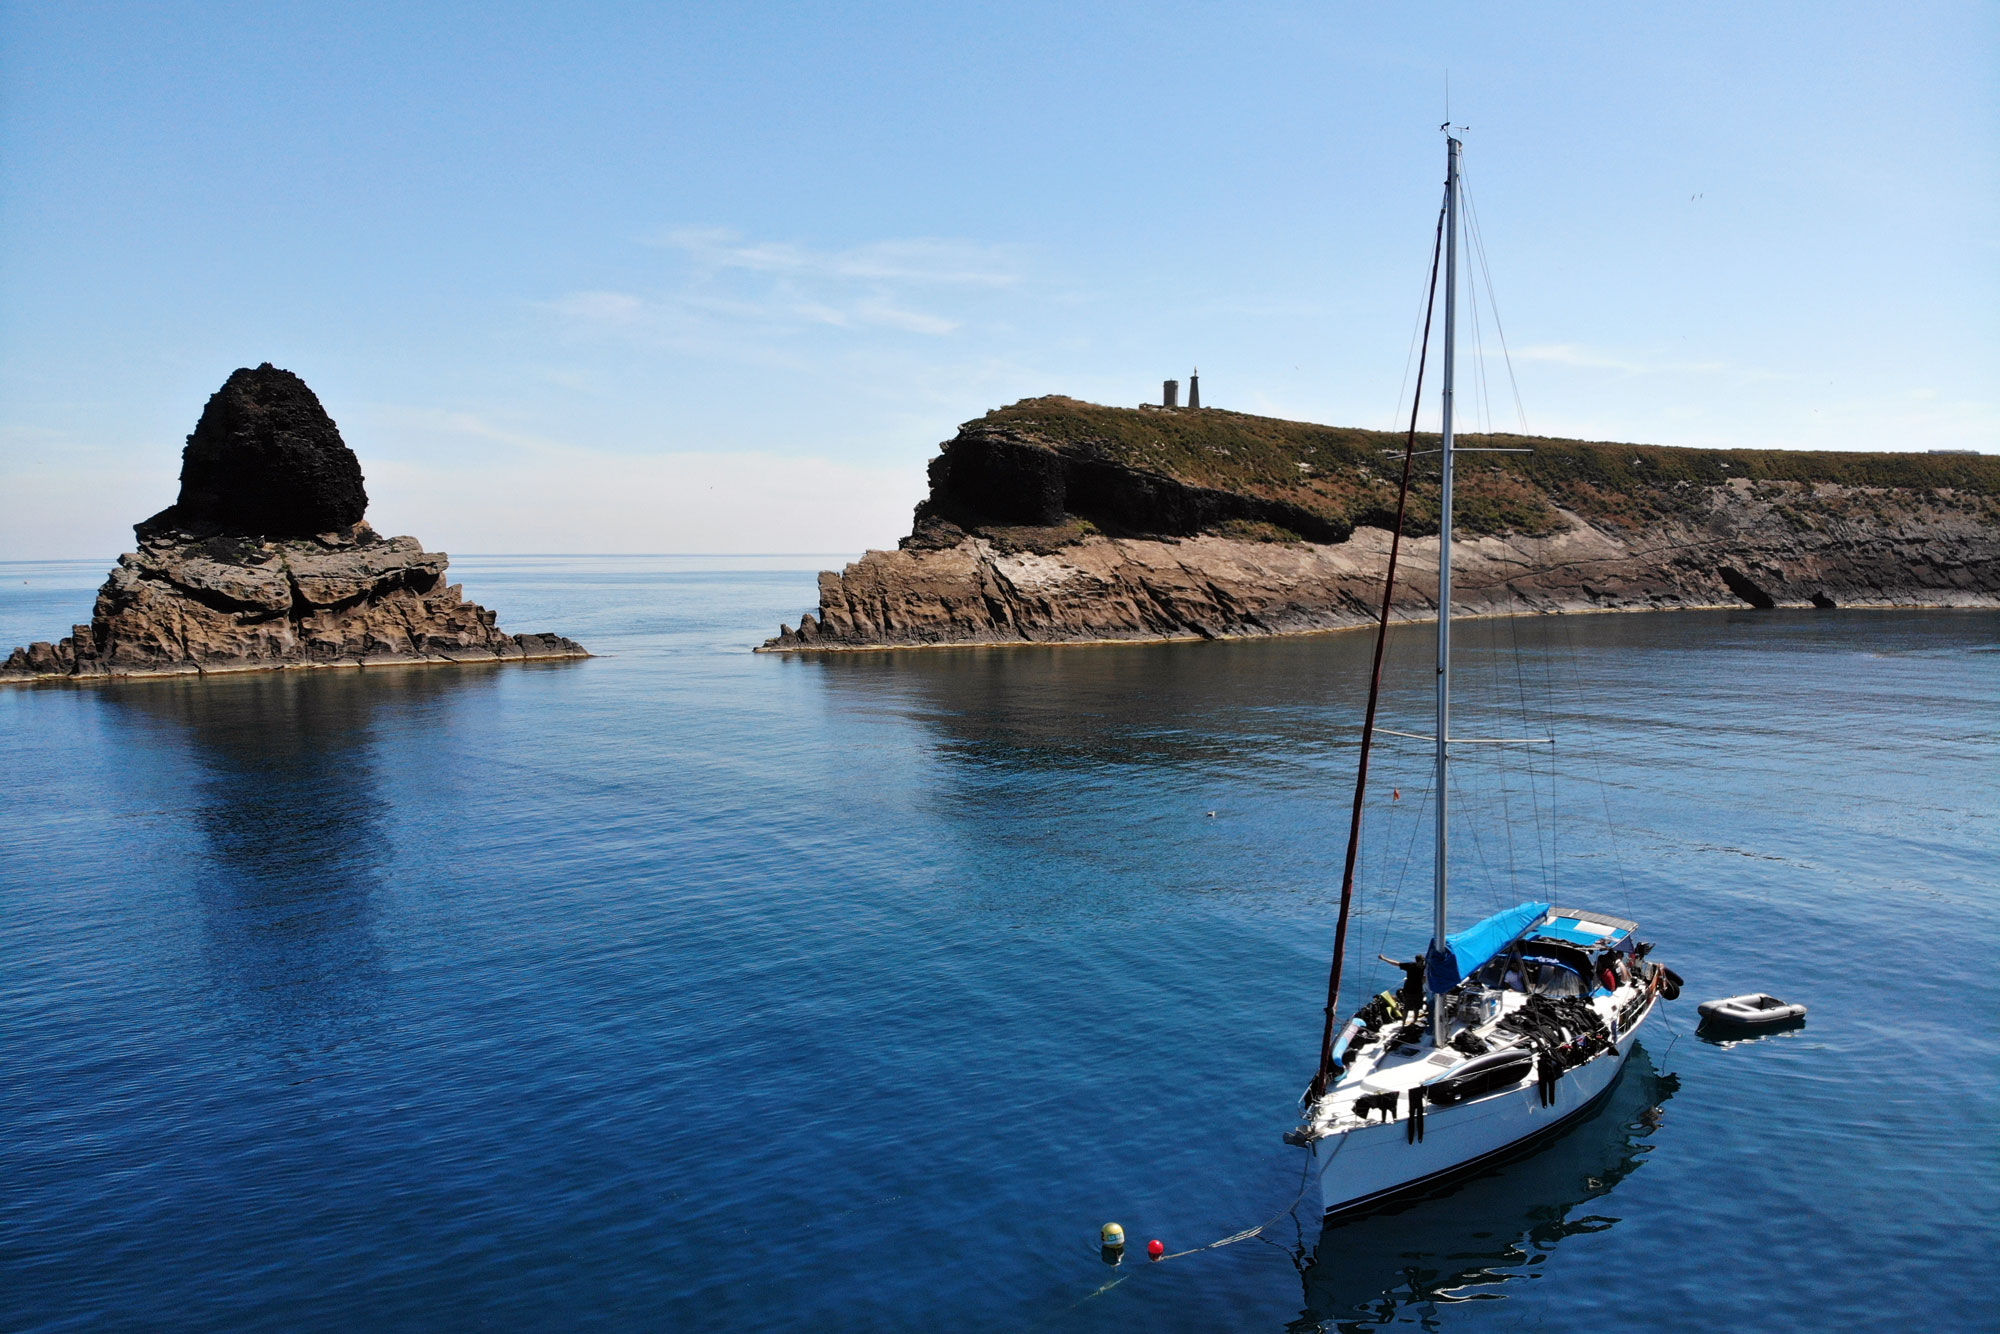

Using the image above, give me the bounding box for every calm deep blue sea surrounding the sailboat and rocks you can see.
[0,558,2000,1330]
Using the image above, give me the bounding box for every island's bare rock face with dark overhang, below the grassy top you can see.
[764,410,2000,652]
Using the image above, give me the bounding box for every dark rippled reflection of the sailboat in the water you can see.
[1286,1046,1680,1334]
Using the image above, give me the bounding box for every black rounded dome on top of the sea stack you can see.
[140,362,368,538]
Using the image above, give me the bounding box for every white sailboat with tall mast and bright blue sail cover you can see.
[1286,133,1680,1218]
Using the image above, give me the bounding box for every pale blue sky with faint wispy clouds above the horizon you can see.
[0,0,2000,560]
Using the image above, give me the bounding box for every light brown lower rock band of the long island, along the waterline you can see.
[764,496,2000,650]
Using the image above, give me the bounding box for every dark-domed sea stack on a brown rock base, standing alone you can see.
[0,362,590,682]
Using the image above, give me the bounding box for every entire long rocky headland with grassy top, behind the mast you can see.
[764,398,2000,652]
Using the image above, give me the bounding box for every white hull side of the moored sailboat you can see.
[1312,992,1652,1214]
